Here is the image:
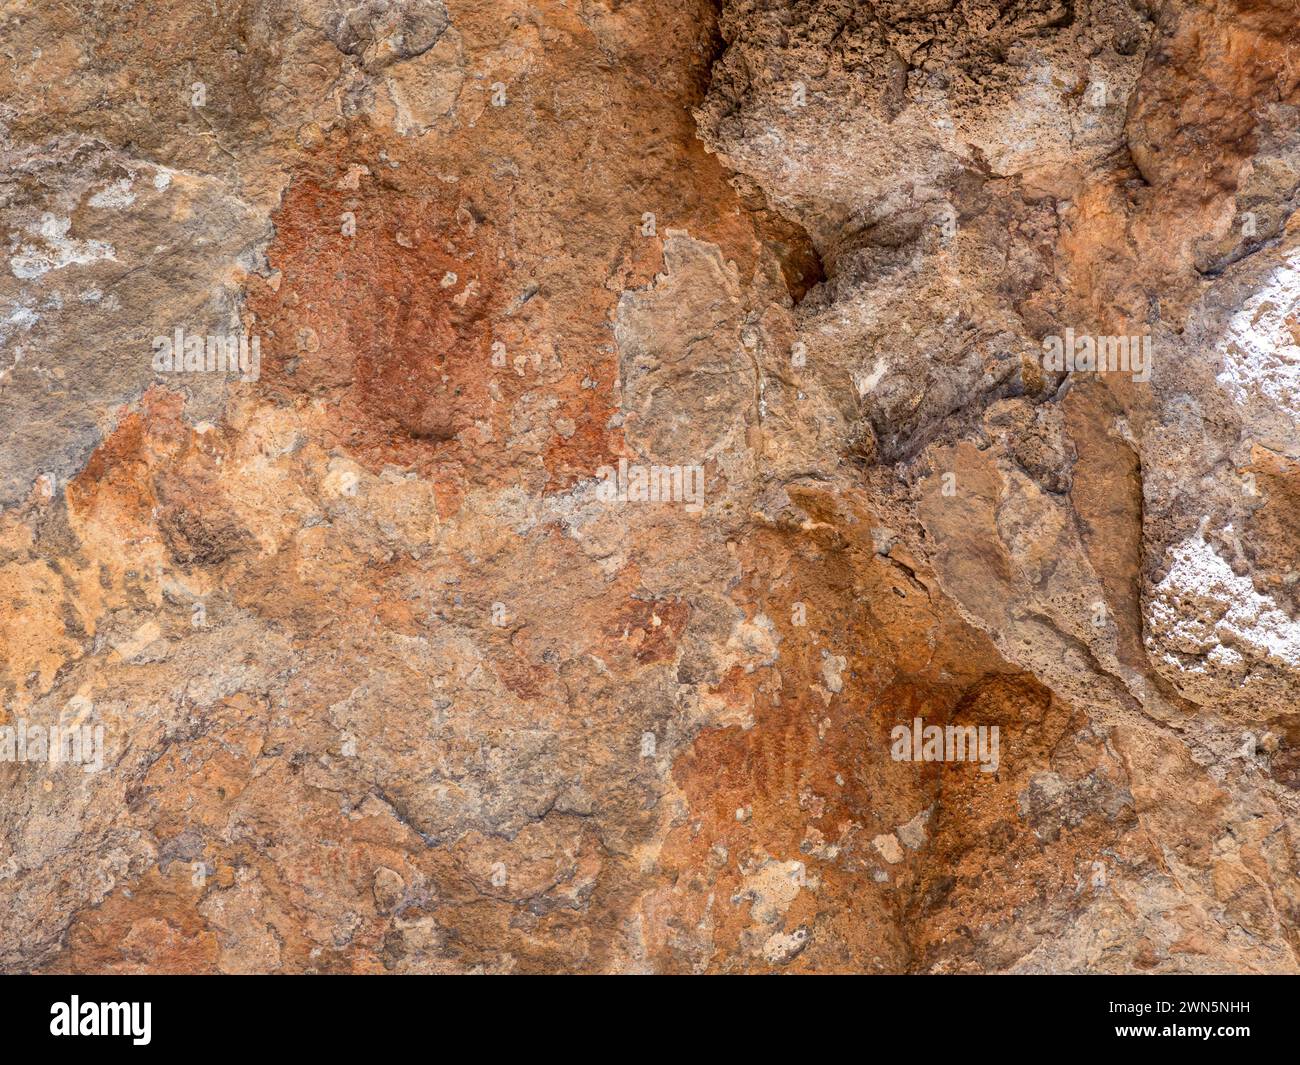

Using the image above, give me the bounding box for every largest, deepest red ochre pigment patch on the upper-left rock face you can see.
[251,170,501,468]
